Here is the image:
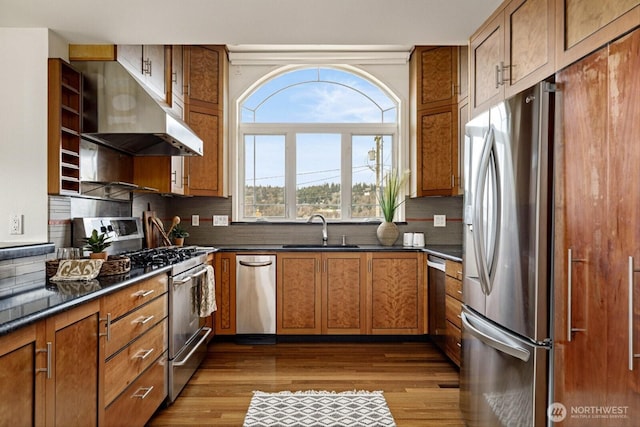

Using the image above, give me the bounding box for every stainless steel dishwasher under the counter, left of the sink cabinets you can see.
[236,255,276,344]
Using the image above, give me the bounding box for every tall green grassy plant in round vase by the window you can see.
[376,170,409,246]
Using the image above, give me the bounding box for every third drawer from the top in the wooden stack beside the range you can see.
[104,319,167,405]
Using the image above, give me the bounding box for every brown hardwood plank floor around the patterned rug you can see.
[148,341,463,427]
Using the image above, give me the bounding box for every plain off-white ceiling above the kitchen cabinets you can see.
[0,0,502,49]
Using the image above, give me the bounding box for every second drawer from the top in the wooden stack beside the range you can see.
[105,294,168,358]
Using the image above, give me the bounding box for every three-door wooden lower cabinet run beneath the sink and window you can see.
[276,252,425,335]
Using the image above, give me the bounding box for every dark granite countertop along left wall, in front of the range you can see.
[0,266,171,336]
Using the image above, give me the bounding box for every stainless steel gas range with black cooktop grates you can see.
[126,247,212,403]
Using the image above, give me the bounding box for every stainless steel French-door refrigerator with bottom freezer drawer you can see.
[460,82,553,427]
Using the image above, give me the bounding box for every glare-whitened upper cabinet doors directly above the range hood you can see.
[117,45,167,99]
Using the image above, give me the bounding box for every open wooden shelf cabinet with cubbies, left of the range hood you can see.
[47,59,82,194]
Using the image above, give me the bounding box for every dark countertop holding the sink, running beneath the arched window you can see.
[215,244,462,261]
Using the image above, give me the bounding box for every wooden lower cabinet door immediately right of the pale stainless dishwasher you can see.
[276,252,322,335]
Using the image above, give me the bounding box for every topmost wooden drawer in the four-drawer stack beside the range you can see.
[102,274,169,320]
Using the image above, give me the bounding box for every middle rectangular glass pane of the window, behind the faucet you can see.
[296,133,341,219]
